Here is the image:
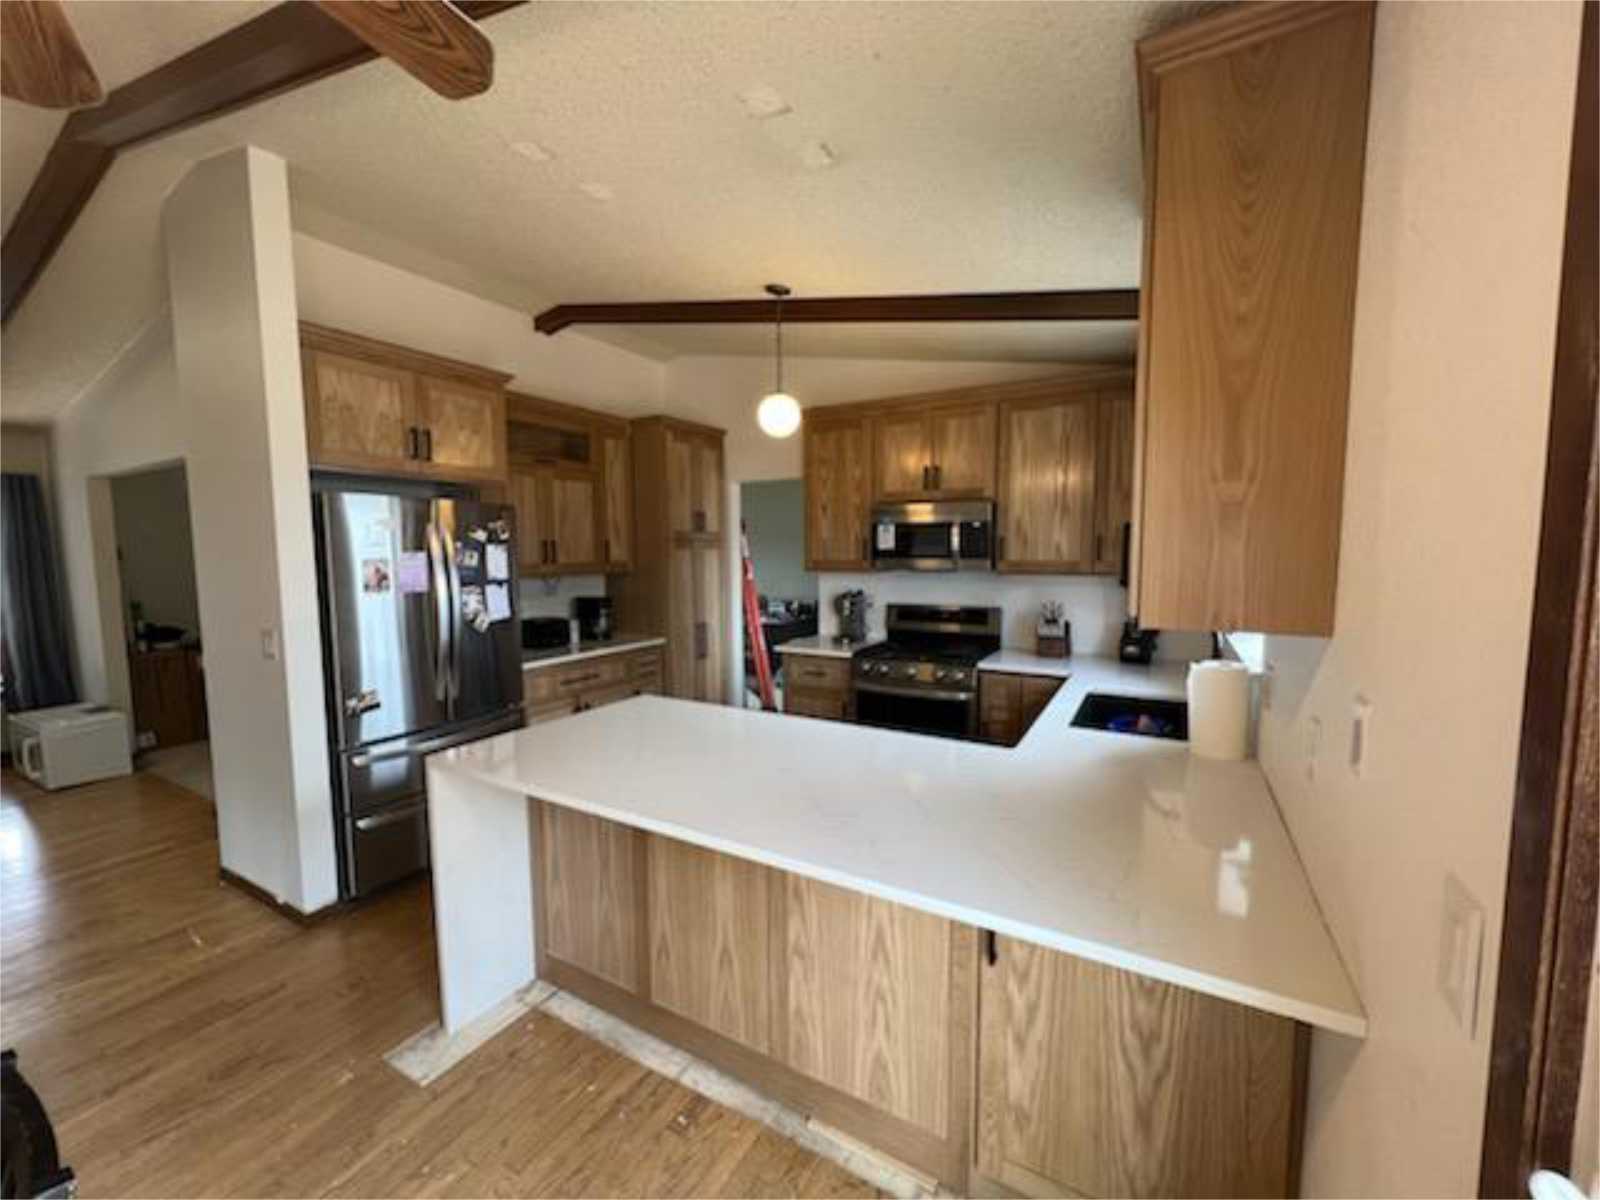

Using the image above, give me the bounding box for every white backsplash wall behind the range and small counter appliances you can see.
[816,571,1211,661]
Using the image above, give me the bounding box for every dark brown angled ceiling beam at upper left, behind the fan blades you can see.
[0,0,522,322]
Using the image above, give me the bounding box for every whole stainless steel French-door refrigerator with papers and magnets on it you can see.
[312,480,522,898]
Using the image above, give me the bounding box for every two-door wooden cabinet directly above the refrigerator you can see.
[301,329,510,482]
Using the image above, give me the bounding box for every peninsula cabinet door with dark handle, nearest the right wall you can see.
[976,938,1304,1197]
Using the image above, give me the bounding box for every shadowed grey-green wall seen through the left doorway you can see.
[110,464,200,634]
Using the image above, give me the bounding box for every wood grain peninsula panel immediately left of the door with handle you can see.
[784,875,952,1133]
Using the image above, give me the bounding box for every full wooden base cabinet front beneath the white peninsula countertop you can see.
[533,802,1309,1197]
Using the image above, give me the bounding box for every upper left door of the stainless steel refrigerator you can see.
[318,491,448,749]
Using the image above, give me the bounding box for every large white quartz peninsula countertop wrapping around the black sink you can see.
[432,658,1366,1037]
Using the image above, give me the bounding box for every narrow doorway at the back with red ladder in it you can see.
[739,478,816,709]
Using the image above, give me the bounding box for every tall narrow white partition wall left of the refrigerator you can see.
[162,147,338,912]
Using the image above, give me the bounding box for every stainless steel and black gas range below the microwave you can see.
[851,605,1000,738]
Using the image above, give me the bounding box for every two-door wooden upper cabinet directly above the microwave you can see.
[872,400,995,501]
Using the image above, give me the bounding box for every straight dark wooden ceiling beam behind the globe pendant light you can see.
[533,288,1139,333]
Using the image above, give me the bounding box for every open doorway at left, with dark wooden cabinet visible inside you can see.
[110,462,214,800]
